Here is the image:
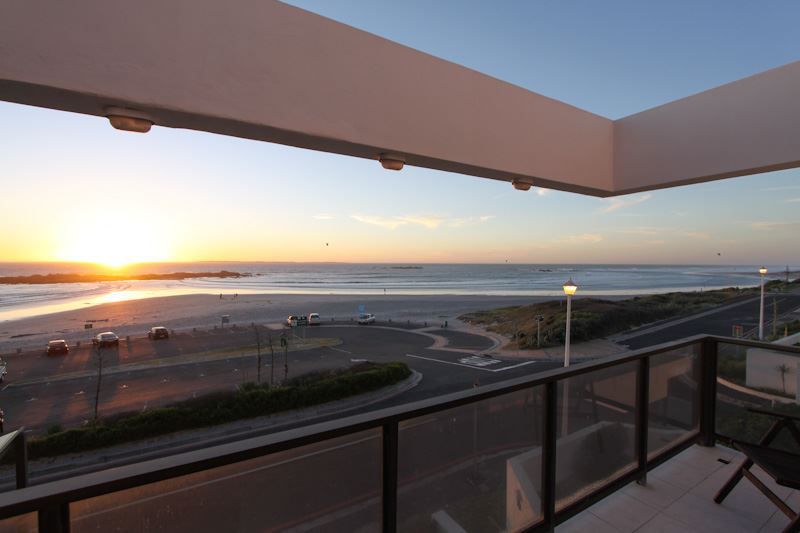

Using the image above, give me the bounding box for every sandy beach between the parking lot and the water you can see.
[0,294,552,353]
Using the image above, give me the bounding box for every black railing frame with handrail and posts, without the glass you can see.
[0,335,800,533]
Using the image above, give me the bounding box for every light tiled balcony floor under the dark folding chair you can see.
[556,446,800,533]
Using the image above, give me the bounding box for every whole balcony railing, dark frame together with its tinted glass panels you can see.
[0,336,800,532]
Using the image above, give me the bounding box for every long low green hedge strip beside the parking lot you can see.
[21,363,411,459]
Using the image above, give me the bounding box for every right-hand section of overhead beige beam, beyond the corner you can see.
[614,61,800,192]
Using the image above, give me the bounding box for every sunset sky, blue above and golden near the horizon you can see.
[0,0,800,265]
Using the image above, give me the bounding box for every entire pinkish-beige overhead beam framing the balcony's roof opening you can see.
[0,0,800,196]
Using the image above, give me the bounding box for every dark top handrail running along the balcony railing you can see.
[0,335,800,519]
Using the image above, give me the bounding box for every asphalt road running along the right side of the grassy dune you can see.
[620,294,800,349]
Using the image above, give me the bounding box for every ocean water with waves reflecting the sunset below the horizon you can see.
[0,262,797,321]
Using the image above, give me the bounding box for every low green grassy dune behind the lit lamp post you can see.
[459,282,752,349]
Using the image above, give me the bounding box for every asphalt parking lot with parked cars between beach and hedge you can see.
[0,325,555,432]
